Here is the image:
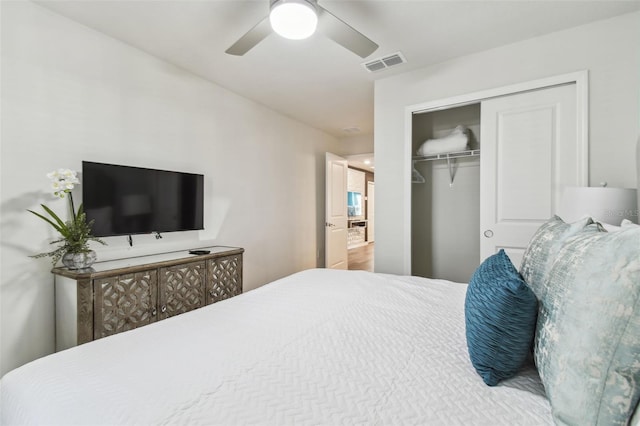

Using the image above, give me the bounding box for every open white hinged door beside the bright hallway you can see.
[324,152,349,269]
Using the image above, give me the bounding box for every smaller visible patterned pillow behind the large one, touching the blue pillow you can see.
[520,216,593,300]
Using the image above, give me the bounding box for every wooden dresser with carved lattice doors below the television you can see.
[52,246,244,351]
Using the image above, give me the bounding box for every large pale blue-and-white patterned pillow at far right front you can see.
[534,224,640,425]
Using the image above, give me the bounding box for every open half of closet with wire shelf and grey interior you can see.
[411,103,482,282]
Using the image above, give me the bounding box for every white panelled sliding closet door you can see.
[480,84,586,267]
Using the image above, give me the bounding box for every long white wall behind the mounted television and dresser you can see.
[0,2,341,374]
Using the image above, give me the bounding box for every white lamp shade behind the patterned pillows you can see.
[558,187,638,226]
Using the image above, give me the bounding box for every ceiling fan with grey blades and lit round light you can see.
[225,0,378,58]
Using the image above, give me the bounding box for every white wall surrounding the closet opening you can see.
[375,12,640,274]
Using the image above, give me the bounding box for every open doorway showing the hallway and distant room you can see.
[345,153,375,272]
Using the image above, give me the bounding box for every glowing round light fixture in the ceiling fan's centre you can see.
[269,0,318,40]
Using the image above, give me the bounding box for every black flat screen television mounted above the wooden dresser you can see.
[82,161,204,237]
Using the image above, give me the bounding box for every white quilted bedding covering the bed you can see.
[0,269,552,425]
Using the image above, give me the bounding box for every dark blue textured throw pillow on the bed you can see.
[464,250,538,386]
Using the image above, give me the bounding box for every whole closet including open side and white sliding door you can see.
[411,82,587,282]
